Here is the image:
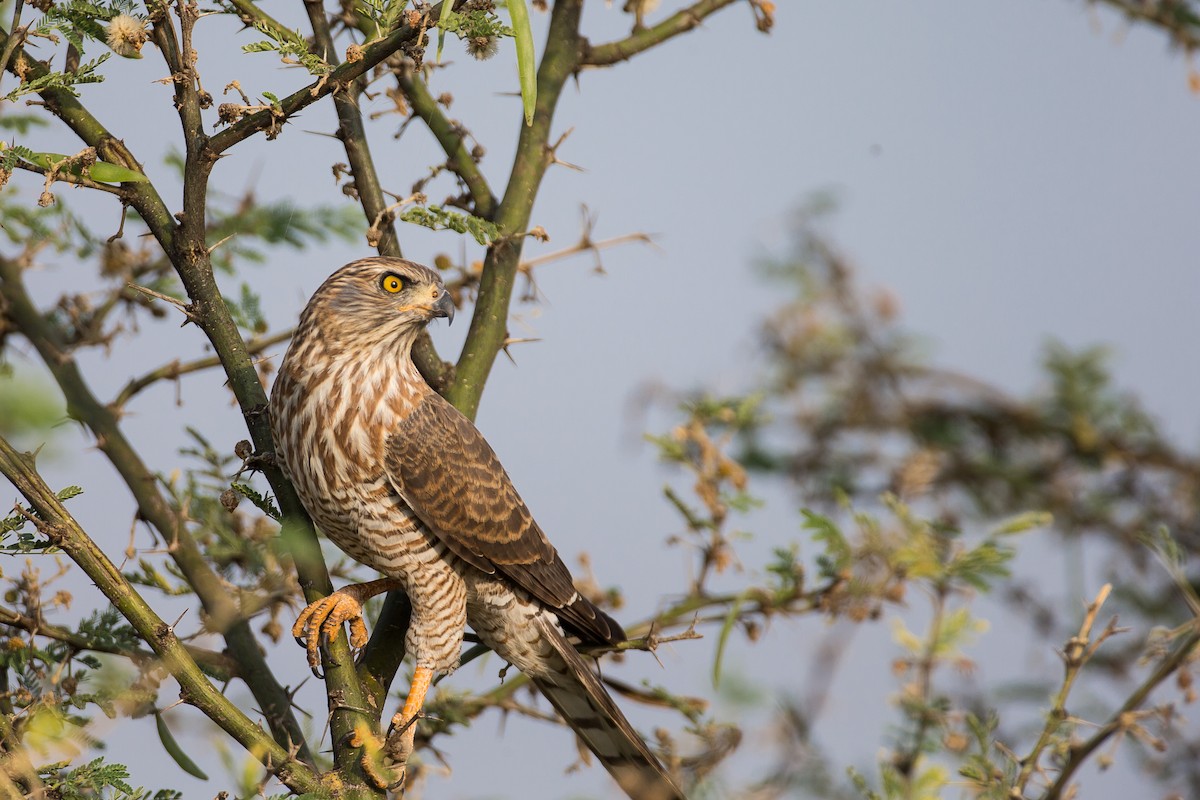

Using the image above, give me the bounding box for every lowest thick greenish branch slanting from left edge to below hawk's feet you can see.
[0,437,324,793]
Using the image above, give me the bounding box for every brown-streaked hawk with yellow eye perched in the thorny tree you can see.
[271,258,683,800]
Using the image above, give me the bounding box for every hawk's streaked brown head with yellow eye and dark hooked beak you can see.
[300,257,455,343]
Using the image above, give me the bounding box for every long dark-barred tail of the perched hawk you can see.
[533,618,686,800]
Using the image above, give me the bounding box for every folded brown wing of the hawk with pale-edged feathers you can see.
[385,392,625,643]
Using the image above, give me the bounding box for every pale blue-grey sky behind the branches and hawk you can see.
[5,0,1200,799]
